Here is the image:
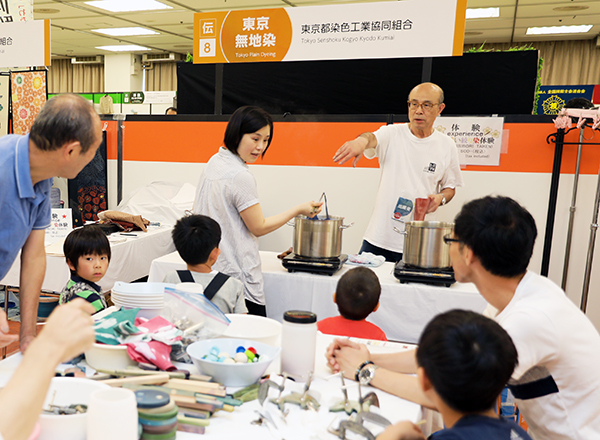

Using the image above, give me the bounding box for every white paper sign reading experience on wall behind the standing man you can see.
[433,116,504,166]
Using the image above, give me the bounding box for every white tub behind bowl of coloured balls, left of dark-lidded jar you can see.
[222,313,281,347]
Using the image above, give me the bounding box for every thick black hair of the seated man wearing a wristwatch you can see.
[454,196,537,278]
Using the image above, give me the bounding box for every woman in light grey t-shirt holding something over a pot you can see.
[194,106,321,316]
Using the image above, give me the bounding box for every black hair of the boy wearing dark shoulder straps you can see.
[172,214,221,266]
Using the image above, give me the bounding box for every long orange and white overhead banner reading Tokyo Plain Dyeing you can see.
[194,0,467,63]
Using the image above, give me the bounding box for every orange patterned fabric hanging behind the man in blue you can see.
[10,70,47,134]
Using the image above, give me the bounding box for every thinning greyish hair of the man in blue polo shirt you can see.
[29,94,98,153]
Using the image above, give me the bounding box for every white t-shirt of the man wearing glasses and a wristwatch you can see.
[486,272,600,440]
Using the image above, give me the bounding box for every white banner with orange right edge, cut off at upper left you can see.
[0,19,50,68]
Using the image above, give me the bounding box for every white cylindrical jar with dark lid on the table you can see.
[281,310,317,382]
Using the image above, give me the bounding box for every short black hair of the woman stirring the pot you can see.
[223,105,273,157]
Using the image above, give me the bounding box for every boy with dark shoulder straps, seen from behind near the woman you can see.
[164,214,248,313]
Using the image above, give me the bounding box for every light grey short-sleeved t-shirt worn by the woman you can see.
[194,147,265,305]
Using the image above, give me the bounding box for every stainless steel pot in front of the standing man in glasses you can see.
[394,221,454,269]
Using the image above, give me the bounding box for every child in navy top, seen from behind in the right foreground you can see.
[377,310,531,440]
